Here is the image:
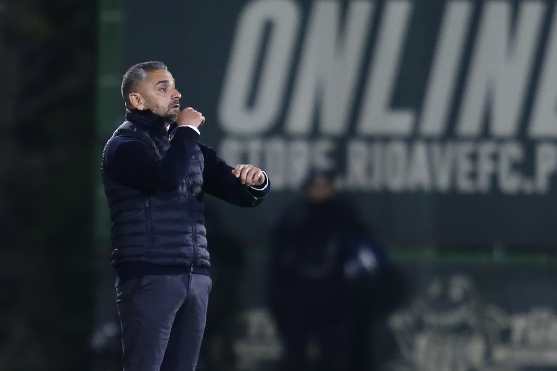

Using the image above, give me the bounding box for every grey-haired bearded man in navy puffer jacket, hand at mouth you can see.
[103,62,270,371]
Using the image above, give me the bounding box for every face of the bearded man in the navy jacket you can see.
[130,70,182,120]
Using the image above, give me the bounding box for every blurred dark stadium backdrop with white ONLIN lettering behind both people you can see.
[0,0,557,371]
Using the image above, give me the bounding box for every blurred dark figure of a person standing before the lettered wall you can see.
[270,172,396,371]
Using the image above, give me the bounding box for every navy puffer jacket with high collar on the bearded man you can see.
[102,111,270,268]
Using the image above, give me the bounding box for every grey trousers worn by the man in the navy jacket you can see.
[116,273,212,371]
